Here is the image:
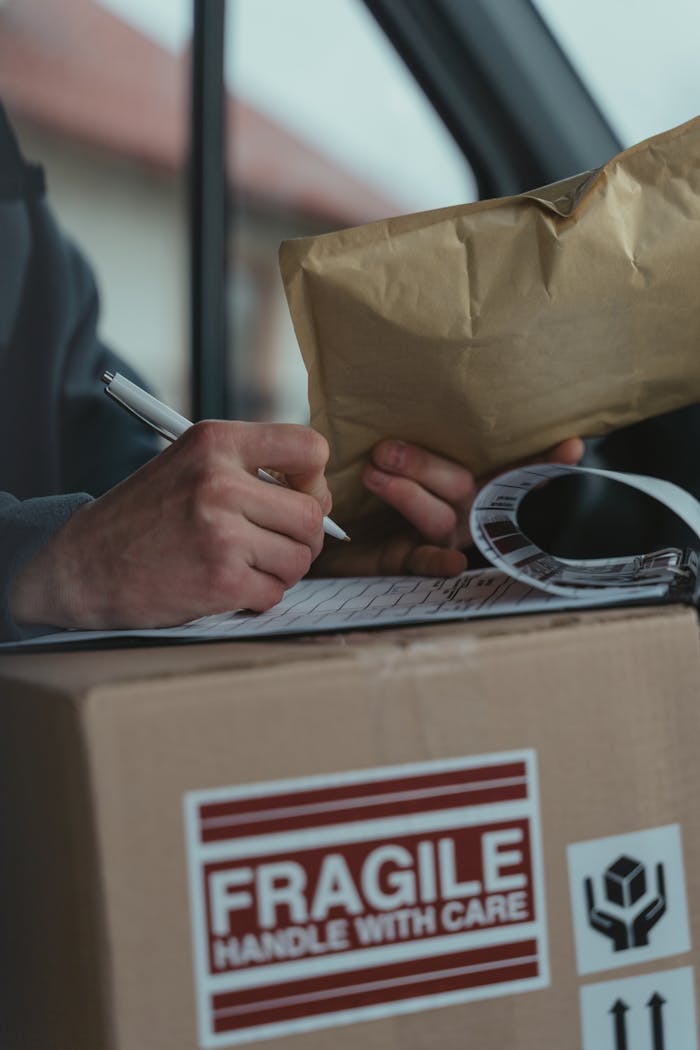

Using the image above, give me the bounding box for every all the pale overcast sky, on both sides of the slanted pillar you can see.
[101,0,700,204]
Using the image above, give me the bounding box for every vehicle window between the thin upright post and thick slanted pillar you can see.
[226,0,475,420]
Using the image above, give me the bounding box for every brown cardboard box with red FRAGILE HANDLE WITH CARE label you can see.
[0,607,700,1050]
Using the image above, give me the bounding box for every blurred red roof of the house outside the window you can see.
[0,0,399,224]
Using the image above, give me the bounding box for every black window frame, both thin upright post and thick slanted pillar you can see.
[190,0,621,419]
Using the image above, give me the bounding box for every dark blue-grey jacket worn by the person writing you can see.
[0,107,156,641]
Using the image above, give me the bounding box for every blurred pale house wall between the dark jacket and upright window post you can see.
[16,122,189,412]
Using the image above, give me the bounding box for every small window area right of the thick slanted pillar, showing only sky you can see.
[534,0,700,146]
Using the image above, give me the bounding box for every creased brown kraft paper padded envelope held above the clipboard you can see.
[280,118,700,521]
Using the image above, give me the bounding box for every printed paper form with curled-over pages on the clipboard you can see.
[0,464,700,651]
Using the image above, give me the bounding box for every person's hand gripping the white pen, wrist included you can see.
[10,422,331,629]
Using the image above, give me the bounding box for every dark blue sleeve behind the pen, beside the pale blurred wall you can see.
[8,202,158,499]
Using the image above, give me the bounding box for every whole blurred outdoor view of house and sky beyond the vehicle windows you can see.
[0,0,700,421]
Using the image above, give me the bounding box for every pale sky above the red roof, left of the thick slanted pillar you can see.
[101,0,474,211]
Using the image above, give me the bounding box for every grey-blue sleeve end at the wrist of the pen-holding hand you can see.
[0,492,90,642]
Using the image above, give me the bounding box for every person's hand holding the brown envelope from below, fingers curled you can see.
[314,438,584,576]
